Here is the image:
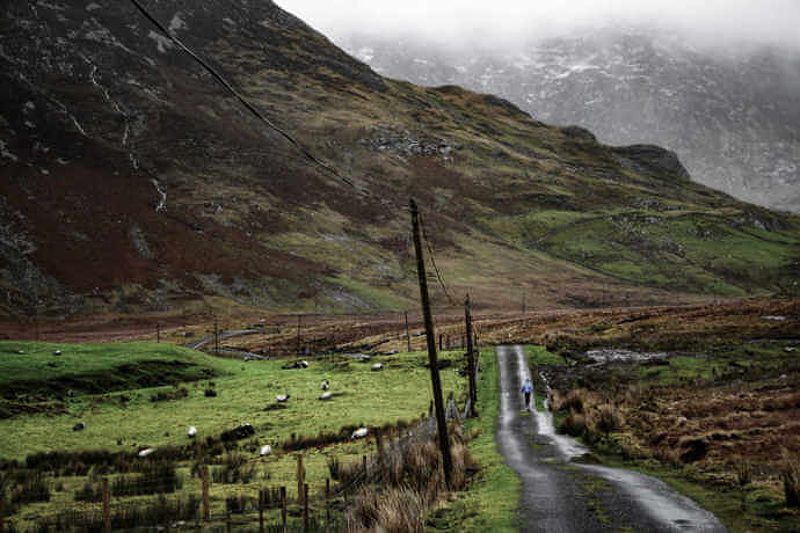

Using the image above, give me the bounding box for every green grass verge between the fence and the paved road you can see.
[429,348,522,531]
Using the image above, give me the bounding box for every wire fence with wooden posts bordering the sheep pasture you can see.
[9,394,469,533]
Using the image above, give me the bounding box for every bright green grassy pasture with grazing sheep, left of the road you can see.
[0,342,464,525]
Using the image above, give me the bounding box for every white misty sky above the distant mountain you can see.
[276,0,800,49]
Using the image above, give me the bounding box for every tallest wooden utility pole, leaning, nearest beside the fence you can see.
[408,198,453,488]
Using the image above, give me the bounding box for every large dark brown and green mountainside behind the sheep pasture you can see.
[0,0,800,317]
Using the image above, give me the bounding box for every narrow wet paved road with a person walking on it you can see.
[497,346,725,533]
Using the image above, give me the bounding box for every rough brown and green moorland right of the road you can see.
[548,341,800,531]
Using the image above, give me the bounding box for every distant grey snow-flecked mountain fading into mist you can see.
[339,29,800,212]
